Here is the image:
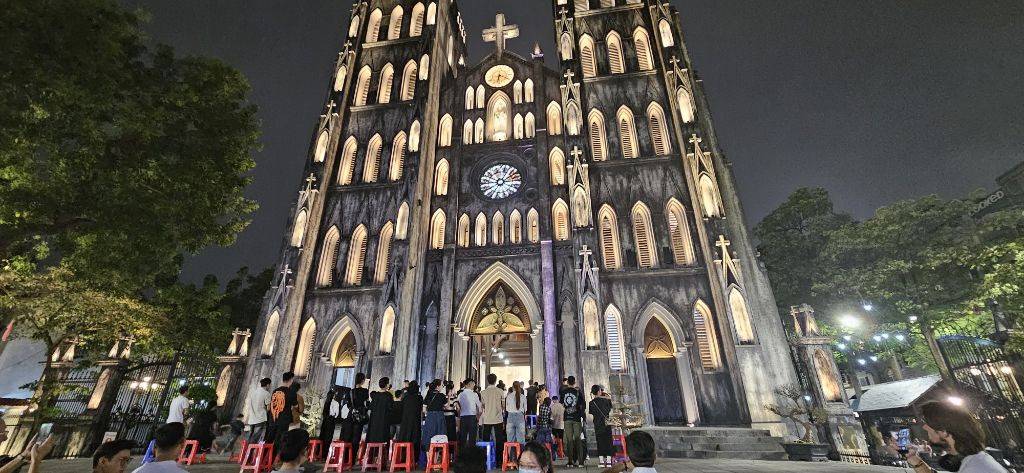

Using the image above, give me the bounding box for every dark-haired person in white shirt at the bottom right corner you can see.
[906,401,1007,473]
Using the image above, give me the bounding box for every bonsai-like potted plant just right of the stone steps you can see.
[765,384,828,462]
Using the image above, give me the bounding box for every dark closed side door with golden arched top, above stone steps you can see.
[643,316,686,425]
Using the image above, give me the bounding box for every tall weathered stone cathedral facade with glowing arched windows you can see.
[243,0,796,433]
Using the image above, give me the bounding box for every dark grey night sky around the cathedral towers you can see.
[125,0,1024,281]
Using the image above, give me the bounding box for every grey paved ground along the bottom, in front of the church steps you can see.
[42,457,902,473]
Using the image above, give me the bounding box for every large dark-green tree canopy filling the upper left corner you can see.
[0,0,258,289]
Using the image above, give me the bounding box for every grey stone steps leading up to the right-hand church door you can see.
[643,427,786,460]
